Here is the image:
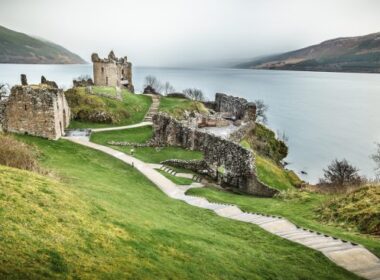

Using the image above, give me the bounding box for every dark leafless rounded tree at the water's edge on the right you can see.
[320,159,363,187]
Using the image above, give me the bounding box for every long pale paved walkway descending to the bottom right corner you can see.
[65,135,380,280]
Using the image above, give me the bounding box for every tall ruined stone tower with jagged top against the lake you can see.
[91,51,134,92]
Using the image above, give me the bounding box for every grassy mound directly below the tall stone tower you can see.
[66,87,152,128]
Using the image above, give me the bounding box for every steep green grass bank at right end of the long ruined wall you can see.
[256,155,301,190]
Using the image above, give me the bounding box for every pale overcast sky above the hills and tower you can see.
[0,0,380,66]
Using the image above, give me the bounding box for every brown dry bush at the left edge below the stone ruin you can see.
[0,134,41,172]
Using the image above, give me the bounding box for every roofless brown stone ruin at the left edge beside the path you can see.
[3,86,70,139]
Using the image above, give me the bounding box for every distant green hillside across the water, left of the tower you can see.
[0,26,85,64]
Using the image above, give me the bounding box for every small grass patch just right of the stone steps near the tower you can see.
[159,97,207,119]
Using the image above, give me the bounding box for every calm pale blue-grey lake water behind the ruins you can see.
[0,64,380,182]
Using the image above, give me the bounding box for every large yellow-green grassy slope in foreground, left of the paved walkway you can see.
[0,136,356,279]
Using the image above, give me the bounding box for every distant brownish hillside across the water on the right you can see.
[235,32,380,73]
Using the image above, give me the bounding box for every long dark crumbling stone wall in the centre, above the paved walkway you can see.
[152,114,277,196]
